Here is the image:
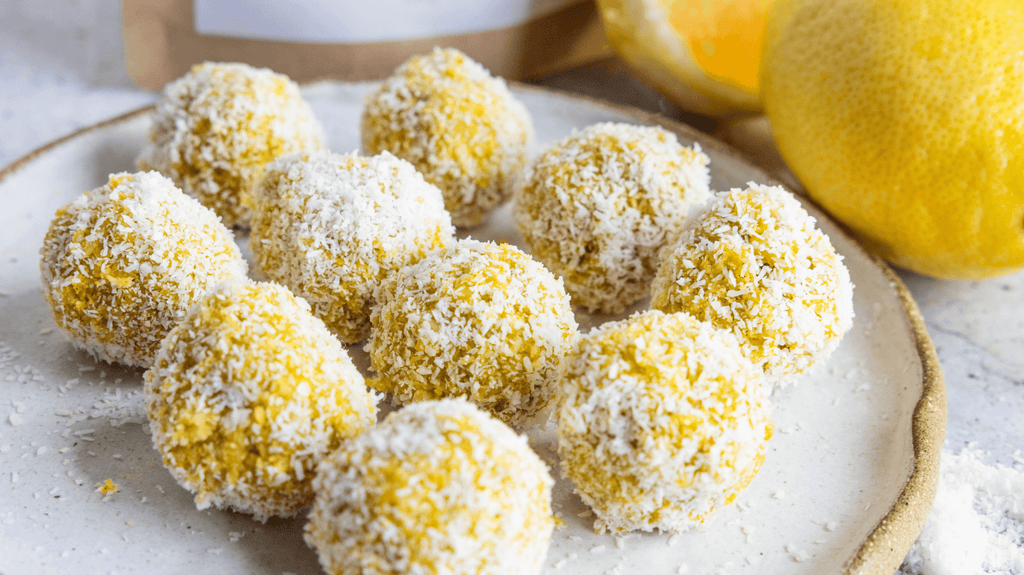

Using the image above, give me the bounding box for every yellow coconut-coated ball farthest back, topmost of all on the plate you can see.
[362,48,534,227]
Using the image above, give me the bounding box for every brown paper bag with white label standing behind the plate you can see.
[123,0,612,90]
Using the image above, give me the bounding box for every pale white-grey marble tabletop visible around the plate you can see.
[0,0,1024,568]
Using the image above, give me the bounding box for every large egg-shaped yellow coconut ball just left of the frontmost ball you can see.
[145,281,377,520]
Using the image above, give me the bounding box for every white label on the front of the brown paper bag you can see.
[193,0,581,44]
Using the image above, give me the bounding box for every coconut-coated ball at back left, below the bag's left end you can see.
[135,62,324,227]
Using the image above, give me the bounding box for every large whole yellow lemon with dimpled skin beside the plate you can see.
[762,0,1024,278]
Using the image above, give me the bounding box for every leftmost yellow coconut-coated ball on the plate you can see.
[39,172,247,367]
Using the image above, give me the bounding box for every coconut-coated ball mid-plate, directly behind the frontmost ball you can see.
[367,239,578,426]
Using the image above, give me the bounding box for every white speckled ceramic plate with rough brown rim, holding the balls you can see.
[0,83,944,575]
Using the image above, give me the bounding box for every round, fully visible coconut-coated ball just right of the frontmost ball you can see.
[557,310,772,533]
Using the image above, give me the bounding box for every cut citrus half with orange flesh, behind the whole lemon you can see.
[598,0,772,117]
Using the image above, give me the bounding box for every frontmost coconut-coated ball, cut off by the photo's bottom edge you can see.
[305,399,554,575]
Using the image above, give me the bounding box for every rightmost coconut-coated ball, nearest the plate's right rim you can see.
[651,183,853,386]
